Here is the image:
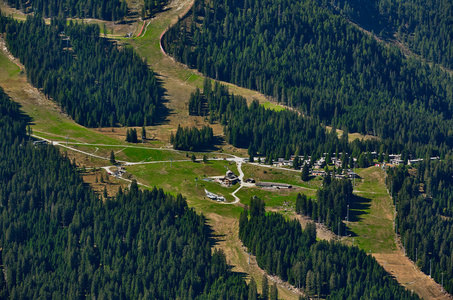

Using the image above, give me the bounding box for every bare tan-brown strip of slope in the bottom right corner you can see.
[373,250,452,299]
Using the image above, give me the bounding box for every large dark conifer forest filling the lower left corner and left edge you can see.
[0,89,251,299]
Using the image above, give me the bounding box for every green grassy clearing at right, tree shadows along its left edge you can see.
[342,167,397,253]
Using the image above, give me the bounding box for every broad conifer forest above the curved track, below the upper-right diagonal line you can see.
[162,0,453,157]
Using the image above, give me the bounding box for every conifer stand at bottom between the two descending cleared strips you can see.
[239,198,418,299]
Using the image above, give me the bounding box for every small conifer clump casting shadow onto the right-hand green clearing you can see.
[296,175,354,235]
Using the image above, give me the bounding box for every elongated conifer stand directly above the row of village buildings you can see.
[189,79,361,160]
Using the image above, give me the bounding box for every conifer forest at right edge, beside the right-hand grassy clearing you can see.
[387,158,453,293]
